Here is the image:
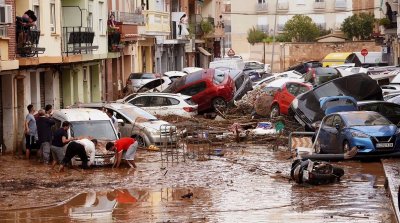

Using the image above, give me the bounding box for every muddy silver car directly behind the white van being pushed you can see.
[74,103,177,147]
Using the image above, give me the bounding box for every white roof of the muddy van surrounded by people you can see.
[53,108,110,122]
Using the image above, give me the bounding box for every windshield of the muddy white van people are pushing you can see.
[71,120,117,140]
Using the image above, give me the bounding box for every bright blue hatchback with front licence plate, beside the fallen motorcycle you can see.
[316,111,400,154]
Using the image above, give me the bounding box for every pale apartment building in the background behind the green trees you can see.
[228,0,353,59]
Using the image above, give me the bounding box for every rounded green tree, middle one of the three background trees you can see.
[283,15,319,42]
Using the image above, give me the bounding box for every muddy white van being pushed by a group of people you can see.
[52,108,118,166]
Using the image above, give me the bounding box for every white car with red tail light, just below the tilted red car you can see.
[120,92,198,118]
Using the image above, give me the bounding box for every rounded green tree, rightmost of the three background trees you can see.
[341,13,375,40]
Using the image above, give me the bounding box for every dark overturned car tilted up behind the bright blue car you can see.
[289,74,383,130]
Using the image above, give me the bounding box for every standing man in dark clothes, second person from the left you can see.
[36,109,55,164]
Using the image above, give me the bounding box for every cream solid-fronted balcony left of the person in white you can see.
[144,11,170,35]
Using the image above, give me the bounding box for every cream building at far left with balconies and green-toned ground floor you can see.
[0,0,108,151]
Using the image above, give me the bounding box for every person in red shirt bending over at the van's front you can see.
[106,137,138,168]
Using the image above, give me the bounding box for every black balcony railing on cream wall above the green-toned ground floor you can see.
[62,27,99,56]
